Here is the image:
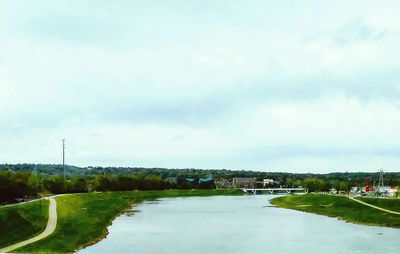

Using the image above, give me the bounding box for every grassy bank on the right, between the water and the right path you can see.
[271,194,400,227]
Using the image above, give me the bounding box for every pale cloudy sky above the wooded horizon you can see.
[0,0,400,173]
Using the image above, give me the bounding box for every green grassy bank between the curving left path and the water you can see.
[17,190,243,253]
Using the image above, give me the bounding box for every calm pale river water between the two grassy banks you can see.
[80,195,400,254]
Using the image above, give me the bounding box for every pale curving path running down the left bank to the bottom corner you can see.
[0,197,57,253]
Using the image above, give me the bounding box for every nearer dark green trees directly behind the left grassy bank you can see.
[0,170,215,203]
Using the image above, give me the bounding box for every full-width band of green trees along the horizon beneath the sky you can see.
[0,164,400,202]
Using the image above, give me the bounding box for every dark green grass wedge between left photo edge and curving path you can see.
[0,200,49,248]
